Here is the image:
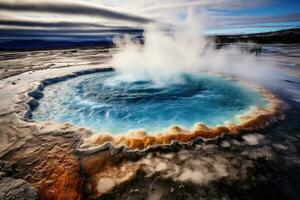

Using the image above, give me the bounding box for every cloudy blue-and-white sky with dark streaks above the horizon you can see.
[0,0,300,38]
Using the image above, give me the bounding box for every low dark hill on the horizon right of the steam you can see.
[213,28,300,44]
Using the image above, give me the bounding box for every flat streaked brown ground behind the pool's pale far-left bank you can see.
[0,47,112,79]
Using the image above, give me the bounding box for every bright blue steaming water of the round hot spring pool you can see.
[32,72,267,134]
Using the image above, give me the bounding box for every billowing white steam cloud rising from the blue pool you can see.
[111,12,275,84]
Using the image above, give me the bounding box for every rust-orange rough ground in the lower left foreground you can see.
[0,123,83,200]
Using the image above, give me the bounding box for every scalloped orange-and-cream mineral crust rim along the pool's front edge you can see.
[81,88,283,150]
